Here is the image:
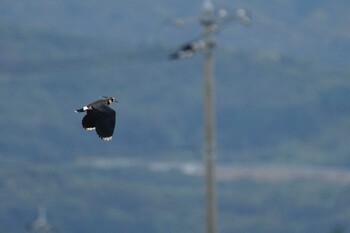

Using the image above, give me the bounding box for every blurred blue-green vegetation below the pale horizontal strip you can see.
[0,161,349,233]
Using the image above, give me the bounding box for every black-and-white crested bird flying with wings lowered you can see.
[75,97,118,141]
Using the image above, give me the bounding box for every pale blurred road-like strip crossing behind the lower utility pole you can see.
[76,158,350,183]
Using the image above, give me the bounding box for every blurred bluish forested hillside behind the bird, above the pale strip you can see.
[1,23,350,165]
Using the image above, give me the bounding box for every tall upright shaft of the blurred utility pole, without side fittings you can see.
[201,0,216,233]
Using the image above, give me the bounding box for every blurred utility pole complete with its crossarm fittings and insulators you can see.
[169,0,251,233]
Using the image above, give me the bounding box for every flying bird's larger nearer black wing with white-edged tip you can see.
[92,104,116,141]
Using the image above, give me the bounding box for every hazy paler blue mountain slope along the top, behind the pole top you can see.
[0,0,350,65]
